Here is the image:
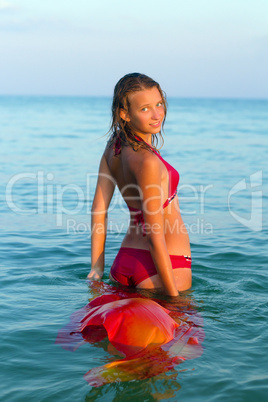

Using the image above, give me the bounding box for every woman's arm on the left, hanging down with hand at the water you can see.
[87,155,116,280]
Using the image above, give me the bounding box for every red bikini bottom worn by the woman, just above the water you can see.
[111,247,192,287]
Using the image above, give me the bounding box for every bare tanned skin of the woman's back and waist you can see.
[104,146,191,255]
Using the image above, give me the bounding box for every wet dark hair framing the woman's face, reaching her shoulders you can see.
[108,73,167,151]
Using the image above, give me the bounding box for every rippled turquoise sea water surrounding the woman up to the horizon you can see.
[0,97,268,401]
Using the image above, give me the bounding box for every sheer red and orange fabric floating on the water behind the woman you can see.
[56,282,204,392]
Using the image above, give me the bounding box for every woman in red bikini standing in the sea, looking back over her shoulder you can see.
[88,73,192,296]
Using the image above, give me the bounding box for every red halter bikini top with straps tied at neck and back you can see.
[114,136,180,236]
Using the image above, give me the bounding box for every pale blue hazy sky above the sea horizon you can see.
[0,0,268,99]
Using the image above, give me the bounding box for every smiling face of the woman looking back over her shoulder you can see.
[120,87,165,136]
